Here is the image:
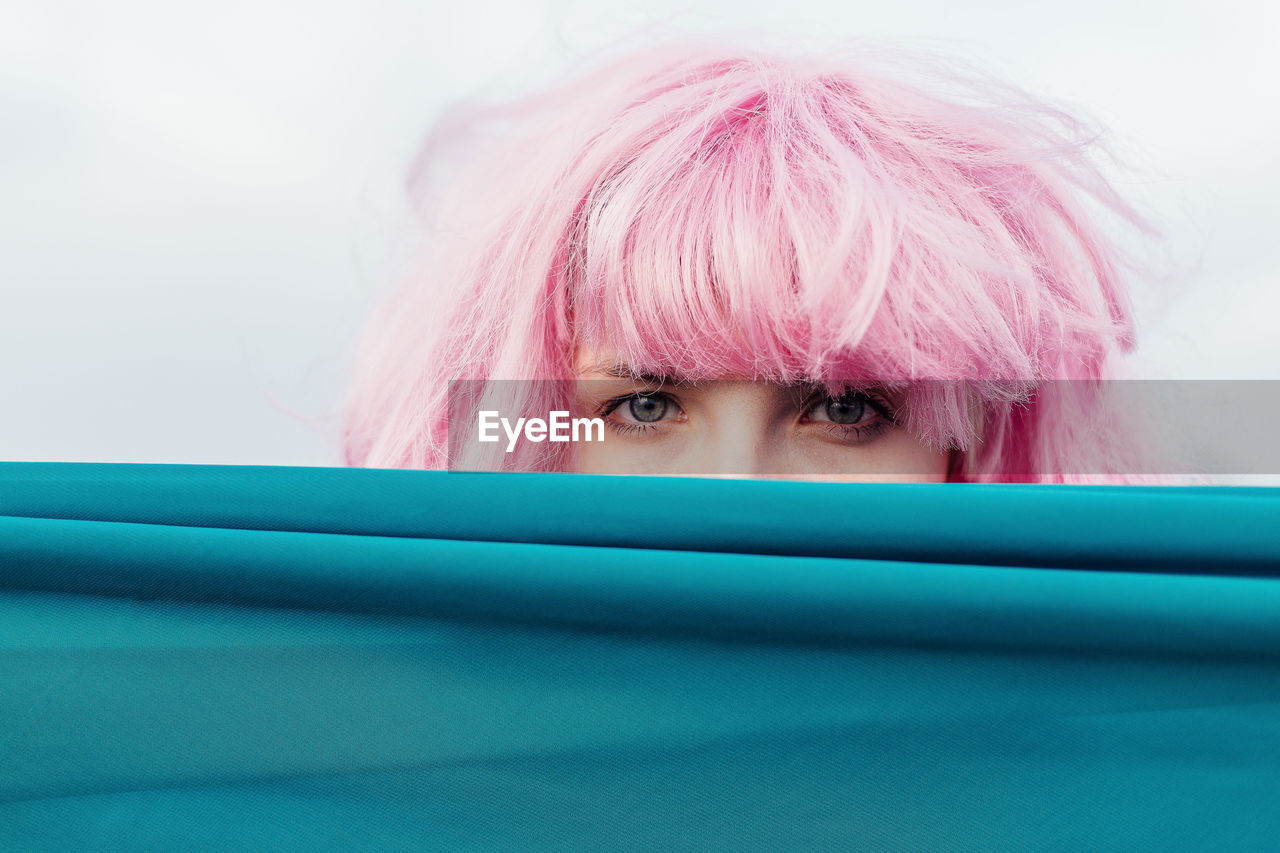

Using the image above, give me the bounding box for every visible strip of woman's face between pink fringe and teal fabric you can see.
[573,351,950,483]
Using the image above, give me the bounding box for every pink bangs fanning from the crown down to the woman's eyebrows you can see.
[567,63,1080,446]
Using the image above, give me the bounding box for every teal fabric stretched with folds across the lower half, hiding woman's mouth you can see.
[0,462,1280,850]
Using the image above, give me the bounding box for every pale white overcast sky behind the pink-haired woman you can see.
[0,0,1280,465]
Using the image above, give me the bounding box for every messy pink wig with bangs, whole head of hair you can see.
[344,36,1162,482]
